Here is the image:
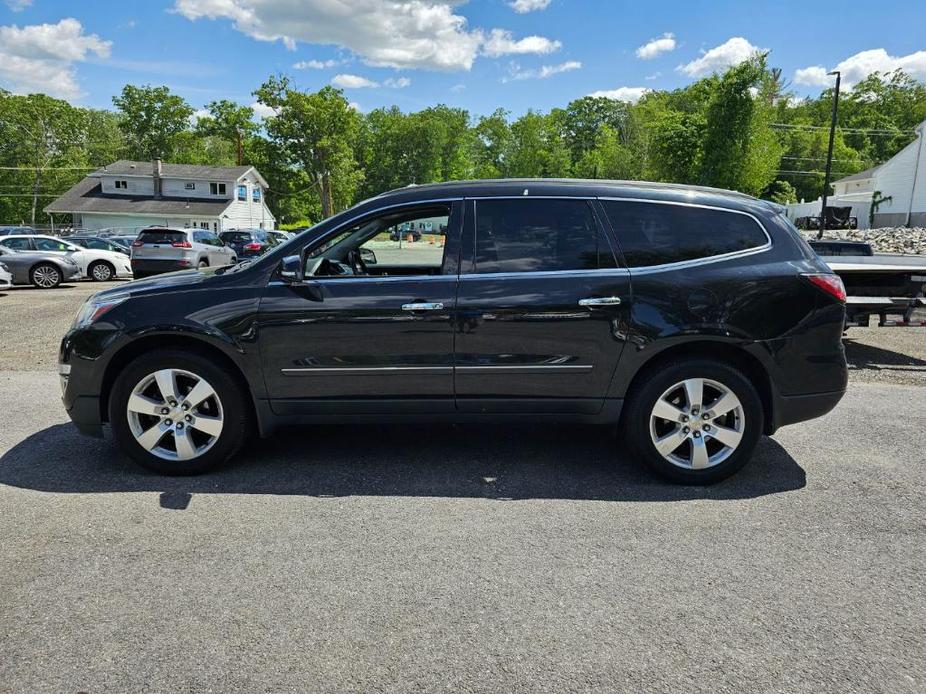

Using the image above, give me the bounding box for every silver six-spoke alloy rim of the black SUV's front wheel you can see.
[126,369,224,461]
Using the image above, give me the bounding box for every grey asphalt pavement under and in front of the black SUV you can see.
[0,371,926,693]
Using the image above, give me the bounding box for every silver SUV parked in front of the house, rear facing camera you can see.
[132,227,238,279]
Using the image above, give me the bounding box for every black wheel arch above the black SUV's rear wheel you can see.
[625,340,775,434]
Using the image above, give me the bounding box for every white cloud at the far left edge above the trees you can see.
[0,18,112,99]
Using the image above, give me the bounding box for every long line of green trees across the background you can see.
[0,55,926,225]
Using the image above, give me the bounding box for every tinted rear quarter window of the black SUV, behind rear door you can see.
[601,200,768,267]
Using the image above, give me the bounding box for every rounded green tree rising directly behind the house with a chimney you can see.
[113,84,193,161]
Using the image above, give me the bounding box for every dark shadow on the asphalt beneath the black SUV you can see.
[0,424,806,508]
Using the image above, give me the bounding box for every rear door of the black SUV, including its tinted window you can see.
[454,197,631,414]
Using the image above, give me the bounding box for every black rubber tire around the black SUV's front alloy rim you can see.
[109,350,252,475]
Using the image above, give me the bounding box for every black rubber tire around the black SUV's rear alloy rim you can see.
[622,359,764,485]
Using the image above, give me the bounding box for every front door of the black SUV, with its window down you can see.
[258,201,462,414]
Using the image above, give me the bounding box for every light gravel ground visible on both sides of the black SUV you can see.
[0,282,926,386]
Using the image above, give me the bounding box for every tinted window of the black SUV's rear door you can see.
[476,199,617,274]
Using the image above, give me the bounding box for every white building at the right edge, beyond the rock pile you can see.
[787,121,926,229]
